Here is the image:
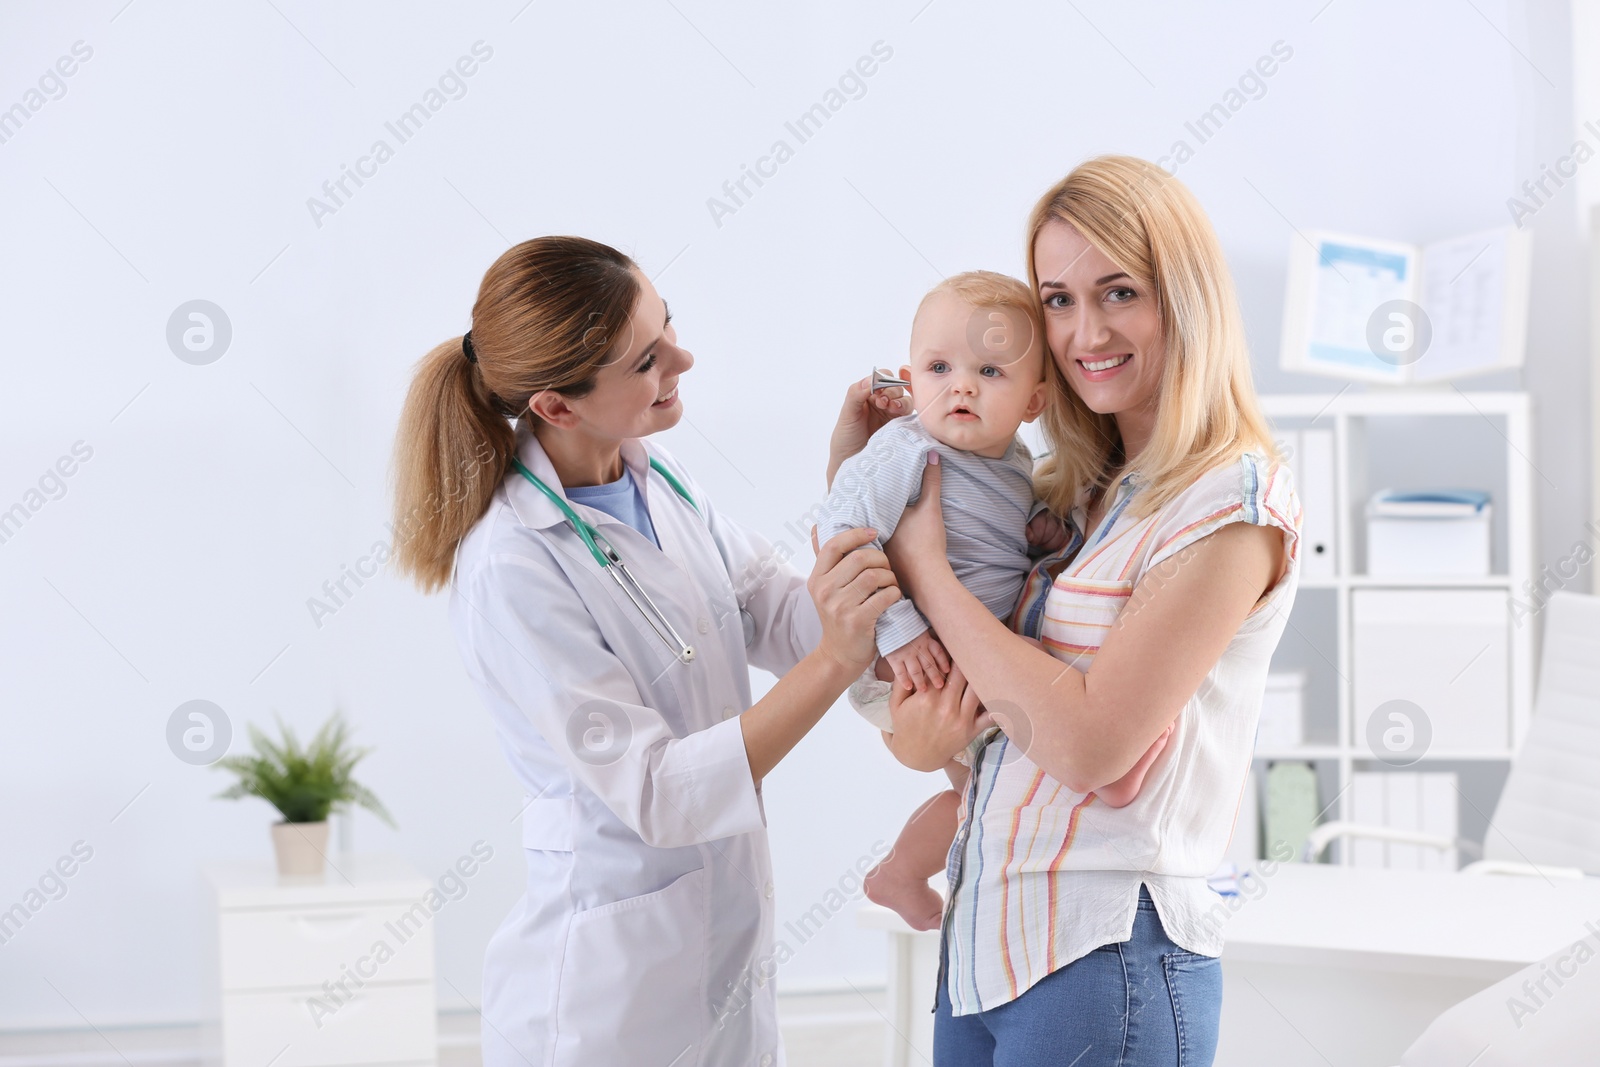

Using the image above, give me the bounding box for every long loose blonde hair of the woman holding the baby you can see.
[1027,155,1278,517]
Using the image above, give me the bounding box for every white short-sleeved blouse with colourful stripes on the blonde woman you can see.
[941,453,1301,1016]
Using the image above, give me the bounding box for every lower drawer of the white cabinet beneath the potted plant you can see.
[222,982,438,1067]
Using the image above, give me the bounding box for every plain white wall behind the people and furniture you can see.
[0,0,1580,1027]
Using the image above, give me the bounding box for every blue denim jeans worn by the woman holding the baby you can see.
[933,885,1222,1067]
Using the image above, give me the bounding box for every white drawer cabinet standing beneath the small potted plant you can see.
[202,854,438,1067]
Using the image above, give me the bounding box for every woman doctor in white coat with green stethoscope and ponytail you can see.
[395,237,909,1067]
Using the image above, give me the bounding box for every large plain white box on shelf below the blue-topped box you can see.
[1350,589,1510,760]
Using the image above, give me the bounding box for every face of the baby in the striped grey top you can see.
[901,293,1046,458]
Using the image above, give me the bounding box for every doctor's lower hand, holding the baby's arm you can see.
[805,526,901,675]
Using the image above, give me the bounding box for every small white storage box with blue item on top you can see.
[1366,490,1491,577]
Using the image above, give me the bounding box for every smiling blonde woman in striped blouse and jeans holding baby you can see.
[864,157,1301,1067]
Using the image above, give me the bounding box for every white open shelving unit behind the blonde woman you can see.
[1256,387,1549,862]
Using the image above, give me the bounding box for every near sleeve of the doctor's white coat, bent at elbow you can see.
[456,545,765,848]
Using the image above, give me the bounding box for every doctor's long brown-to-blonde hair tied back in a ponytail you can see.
[394,237,640,592]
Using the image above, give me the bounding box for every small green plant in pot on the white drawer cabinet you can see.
[213,712,395,875]
